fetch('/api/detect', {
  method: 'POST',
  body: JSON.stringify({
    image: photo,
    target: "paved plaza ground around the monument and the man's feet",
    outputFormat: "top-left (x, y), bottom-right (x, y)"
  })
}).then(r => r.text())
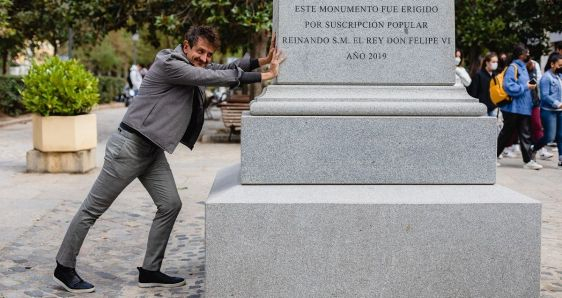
top-left (0, 108), bottom-right (562, 297)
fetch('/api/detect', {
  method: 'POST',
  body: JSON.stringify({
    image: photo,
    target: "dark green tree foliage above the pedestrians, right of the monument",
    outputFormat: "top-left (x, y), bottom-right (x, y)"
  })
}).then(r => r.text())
top-left (455, 0), bottom-right (562, 74)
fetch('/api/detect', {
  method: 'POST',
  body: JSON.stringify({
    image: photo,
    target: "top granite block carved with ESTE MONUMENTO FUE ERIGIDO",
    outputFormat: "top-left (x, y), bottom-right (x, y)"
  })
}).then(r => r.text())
top-left (273, 0), bottom-right (455, 85)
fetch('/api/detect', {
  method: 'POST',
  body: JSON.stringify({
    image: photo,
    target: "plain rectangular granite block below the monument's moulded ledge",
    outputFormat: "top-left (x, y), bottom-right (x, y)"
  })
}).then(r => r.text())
top-left (241, 114), bottom-right (497, 184)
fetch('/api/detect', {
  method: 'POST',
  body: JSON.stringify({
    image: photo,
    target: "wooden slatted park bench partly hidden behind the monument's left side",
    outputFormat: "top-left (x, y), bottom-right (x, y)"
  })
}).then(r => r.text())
top-left (218, 94), bottom-right (250, 142)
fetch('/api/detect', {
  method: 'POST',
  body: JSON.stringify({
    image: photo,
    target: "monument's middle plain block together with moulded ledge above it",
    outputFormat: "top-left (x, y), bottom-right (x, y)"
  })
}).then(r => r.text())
top-left (241, 86), bottom-right (497, 185)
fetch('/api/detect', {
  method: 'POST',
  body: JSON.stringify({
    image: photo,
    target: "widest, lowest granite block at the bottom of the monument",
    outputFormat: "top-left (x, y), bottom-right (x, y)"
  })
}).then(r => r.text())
top-left (205, 167), bottom-right (541, 298)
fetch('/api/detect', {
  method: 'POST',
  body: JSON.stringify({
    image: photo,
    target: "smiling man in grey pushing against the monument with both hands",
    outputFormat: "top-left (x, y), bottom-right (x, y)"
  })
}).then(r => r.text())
top-left (54, 26), bottom-right (281, 293)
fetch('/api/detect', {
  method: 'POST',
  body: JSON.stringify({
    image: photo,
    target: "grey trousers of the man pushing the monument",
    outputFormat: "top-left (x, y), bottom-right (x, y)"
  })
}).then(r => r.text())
top-left (57, 129), bottom-right (182, 271)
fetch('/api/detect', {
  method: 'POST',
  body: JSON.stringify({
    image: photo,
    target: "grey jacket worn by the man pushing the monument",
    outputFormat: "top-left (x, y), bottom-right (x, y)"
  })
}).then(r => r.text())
top-left (123, 45), bottom-right (261, 153)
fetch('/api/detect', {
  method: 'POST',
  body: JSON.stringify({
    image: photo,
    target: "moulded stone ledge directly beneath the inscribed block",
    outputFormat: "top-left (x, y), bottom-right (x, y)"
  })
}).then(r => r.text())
top-left (250, 85), bottom-right (486, 117)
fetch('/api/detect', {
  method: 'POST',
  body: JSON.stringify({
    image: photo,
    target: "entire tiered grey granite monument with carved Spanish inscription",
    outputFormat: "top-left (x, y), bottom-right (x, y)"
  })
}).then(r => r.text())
top-left (206, 0), bottom-right (541, 297)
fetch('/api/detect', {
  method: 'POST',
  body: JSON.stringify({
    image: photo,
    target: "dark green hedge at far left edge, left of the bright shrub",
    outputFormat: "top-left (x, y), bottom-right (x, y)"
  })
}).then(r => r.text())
top-left (0, 76), bottom-right (26, 116)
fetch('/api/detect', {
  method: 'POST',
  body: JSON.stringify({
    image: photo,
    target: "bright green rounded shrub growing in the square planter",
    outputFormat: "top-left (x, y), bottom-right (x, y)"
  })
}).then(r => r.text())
top-left (22, 57), bottom-right (100, 116)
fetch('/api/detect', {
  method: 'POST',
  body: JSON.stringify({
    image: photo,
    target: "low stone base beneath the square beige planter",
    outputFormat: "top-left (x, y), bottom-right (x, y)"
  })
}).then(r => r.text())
top-left (27, 148), bottom-right (96, 173)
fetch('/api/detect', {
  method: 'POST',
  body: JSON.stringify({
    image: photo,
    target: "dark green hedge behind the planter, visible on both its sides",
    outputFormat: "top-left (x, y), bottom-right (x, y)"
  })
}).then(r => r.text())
top-left (0, 75), bottom-right (125, 116)
